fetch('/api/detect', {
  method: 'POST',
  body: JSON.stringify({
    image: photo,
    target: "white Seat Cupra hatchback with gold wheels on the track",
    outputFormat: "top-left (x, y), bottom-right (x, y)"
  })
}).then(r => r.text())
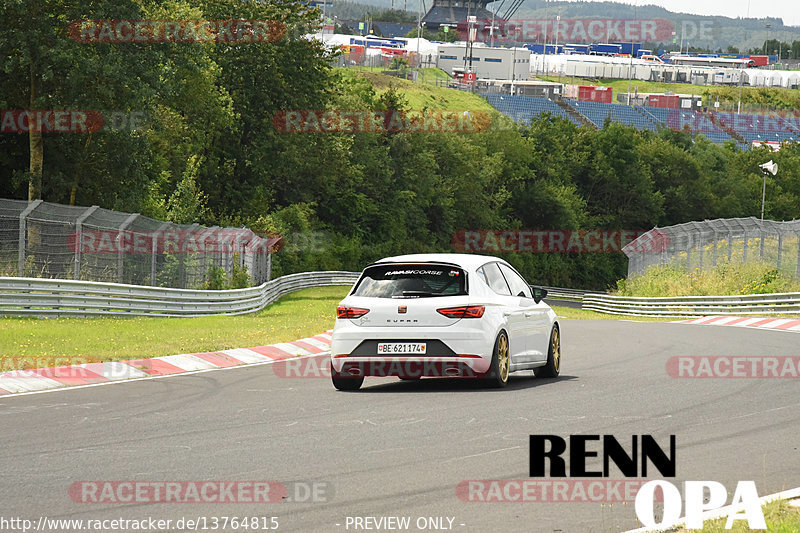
top-left (331, 254), bottom-right (561, 390)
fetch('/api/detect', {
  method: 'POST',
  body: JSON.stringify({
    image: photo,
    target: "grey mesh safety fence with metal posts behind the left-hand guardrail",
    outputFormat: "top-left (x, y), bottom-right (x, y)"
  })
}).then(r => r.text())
top-left (0, 199), bottom-right (280, 288)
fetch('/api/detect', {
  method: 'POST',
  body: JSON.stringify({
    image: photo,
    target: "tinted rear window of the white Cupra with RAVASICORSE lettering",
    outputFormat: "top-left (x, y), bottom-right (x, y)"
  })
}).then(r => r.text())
top-left (353, 264), bottom-right (467, 298)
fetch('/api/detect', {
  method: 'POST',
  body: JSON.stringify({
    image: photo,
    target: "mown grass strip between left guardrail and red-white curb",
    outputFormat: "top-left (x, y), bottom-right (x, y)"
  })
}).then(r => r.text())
top-left (0, 287), bottom-right (348, 370)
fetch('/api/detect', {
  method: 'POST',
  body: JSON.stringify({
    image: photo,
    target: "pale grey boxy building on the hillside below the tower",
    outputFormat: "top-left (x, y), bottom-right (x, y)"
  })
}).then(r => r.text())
top-left (436, 43), bottom-right (531, 80)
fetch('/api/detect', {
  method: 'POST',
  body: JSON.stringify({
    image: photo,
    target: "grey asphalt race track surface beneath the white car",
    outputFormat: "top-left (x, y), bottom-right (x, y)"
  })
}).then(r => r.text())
top-left (0, 321), bottom-right (800, 533)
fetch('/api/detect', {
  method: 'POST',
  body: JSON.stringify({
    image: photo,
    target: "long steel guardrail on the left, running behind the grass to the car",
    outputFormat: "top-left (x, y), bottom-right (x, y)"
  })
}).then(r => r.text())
top-left (0, 271), bottom-right (359, 317)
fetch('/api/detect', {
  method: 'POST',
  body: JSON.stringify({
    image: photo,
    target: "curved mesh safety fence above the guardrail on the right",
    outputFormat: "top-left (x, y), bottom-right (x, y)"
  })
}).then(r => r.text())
top-left (622, 217), bottom-right (800, 278)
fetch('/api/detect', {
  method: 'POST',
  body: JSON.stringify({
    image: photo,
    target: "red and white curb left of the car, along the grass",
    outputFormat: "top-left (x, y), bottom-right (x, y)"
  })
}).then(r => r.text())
top-left (0, 331), bottom-right (331, 396)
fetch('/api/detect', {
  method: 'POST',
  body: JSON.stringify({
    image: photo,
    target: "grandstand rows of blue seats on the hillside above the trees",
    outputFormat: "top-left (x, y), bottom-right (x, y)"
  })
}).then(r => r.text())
top-left (484, 94), bottom-right (800, 148)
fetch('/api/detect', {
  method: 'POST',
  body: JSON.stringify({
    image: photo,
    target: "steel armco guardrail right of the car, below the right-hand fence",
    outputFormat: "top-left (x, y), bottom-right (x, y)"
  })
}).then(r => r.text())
top-left (581, 292), bottom-right (800, 317)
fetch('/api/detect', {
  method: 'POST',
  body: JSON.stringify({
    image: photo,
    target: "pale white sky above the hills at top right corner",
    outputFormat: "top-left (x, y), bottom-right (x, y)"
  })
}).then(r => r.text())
top-left (621, 0), bottom-right (800, 26)
